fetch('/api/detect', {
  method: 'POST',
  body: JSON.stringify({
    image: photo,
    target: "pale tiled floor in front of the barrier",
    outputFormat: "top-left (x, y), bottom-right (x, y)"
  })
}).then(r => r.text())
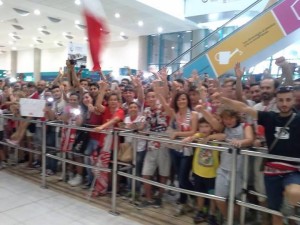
top-left (0, 170), bottom-right (140, 225)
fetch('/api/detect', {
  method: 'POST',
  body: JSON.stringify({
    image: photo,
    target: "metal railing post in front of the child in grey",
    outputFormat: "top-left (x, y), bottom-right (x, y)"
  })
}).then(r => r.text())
top-left (227, 148), bottom-right (237, 225)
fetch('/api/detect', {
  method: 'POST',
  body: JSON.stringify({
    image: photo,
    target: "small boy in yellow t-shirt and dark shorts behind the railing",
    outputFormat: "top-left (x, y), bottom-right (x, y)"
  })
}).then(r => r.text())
top-left (183, 118), bottom-right (219, 225)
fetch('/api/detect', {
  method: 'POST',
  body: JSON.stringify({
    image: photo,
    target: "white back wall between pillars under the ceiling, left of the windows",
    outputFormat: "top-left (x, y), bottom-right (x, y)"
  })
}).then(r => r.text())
top-left (0, 38), bottom-right (139, 76)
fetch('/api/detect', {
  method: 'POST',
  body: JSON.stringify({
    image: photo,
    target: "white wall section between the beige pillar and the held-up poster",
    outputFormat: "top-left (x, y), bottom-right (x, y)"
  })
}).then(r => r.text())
top-left (41, 47), bottom-right (68, 72)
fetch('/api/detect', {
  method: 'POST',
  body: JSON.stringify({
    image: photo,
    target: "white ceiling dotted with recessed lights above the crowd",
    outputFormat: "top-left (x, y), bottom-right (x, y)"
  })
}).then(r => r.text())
top-left (0, 0), bottom-right (197, 51)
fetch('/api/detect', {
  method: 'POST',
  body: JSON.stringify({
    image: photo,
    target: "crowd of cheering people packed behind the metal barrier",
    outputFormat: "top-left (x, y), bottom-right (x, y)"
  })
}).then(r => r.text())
top-left (0, 58), bottom-right (300, 225)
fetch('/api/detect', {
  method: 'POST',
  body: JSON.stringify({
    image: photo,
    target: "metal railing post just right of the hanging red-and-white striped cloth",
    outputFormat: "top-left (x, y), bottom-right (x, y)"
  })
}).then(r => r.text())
top-left (110, 131), bottom-right (119, 216)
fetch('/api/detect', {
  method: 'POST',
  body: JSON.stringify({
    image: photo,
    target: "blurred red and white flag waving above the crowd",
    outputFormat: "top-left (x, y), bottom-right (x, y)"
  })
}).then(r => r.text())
top-left (83, 0), bottom-right (108, 71)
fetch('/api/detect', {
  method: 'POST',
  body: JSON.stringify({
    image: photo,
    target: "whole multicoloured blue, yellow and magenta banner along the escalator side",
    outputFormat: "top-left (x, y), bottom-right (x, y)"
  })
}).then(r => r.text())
top-left (184, 0), bottom-right (300, 77)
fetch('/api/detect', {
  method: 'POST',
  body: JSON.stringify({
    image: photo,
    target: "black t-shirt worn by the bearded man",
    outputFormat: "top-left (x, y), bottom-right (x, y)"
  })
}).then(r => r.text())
top-left (257, 111), bottom-right (300, 164)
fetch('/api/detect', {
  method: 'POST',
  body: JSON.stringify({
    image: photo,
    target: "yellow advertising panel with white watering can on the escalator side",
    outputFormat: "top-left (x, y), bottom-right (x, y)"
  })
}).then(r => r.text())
top-left (207, 12), bottom-right (285, 76)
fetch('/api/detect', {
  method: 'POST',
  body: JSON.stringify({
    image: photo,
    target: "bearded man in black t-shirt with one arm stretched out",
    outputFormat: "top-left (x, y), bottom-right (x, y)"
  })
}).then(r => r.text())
top-left (213, 86), bottom-right (300, 225)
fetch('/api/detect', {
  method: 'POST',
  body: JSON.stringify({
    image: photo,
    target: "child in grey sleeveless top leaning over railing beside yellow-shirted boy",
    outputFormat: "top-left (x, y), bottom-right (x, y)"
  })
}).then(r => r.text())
top-left (204, 109), bottom-right (254, 223)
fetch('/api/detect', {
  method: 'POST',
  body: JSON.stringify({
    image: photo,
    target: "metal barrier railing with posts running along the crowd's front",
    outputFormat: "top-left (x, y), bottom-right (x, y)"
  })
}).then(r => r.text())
top-left (0, 112), bottom-right (300, 224)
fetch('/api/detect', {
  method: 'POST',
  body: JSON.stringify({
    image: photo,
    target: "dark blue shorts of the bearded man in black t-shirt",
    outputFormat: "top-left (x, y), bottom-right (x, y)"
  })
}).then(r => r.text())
top-left (265, 172), bottom-right (300, 211)
